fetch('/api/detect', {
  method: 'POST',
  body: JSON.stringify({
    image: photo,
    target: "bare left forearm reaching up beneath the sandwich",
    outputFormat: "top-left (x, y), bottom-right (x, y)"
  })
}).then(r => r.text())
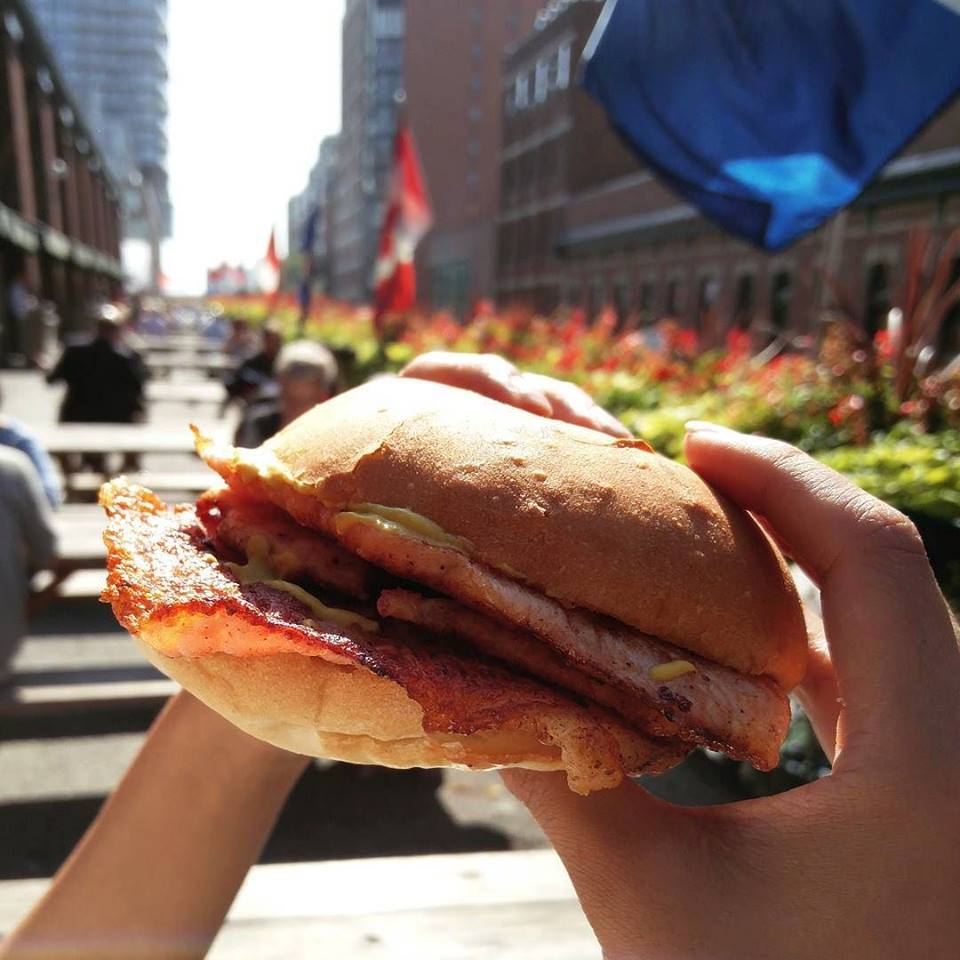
top-left (0, 693), bottom-right (307, 960)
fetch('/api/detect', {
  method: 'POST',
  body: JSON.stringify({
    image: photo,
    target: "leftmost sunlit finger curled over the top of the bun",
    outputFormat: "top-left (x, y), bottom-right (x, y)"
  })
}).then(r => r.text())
top-left (400, 351), bottom-right (553, 417)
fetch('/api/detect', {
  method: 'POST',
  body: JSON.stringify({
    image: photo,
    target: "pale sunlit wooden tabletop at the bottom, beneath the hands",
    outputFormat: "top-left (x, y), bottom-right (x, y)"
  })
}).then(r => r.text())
top-left (0, 852), bottom-right (600, 960)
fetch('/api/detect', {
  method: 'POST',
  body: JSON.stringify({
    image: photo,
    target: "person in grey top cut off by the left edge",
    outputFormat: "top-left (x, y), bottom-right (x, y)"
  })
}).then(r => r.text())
top-left (0, 447), bottom-right (56, 686)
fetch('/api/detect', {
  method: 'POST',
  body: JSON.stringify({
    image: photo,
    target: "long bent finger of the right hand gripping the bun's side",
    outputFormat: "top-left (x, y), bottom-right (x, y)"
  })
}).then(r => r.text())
top-left (686, 424), bottom-right (960, 752)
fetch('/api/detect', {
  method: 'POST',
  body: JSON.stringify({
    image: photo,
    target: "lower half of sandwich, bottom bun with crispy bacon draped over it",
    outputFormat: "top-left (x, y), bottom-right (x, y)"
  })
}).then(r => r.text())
top-left (100, 480), bottom-right (689, 793)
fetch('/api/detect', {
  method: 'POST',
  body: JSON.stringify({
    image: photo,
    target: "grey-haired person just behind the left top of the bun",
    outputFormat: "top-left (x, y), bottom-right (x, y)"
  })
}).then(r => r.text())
top-left (234, 340), bottom-right (339, 447)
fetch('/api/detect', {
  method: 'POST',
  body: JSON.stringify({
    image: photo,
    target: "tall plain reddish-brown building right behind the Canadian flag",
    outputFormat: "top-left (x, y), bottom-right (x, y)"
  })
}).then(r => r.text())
top-left (404, 0), bottom-right (542, 314)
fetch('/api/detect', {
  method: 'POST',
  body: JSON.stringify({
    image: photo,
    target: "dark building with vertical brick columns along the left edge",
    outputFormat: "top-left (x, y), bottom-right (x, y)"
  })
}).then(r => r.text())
top-left (0, 0), bottom-right (123, 351)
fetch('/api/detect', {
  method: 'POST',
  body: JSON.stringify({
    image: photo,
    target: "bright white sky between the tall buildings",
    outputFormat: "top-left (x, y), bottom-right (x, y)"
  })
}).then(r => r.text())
top-left (124, 0), bottom-right (344, 294)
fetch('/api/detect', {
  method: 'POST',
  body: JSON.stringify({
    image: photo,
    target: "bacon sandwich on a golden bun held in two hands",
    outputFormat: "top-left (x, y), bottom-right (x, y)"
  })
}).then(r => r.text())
top-left (101, 378), bottom-right (806, 793)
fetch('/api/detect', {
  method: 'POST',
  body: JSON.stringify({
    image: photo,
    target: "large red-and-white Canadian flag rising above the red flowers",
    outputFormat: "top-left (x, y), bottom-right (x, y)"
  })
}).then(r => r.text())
top-left (373, 123), bottom-right (433, 331)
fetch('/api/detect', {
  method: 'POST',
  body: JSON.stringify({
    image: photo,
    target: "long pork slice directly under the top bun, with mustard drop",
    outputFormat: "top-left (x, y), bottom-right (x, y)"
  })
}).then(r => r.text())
top-left (336, 514), bottom-right (790, 770)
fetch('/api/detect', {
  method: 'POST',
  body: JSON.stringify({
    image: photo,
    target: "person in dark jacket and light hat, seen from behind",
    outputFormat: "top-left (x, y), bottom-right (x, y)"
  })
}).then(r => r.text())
top-left (47, 303), bottom-right (146, 423)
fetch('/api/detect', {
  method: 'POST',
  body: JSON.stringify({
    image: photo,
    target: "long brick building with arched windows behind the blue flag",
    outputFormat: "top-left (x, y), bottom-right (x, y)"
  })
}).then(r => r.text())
top-left (496, 0), bottom-right (960, 344)
